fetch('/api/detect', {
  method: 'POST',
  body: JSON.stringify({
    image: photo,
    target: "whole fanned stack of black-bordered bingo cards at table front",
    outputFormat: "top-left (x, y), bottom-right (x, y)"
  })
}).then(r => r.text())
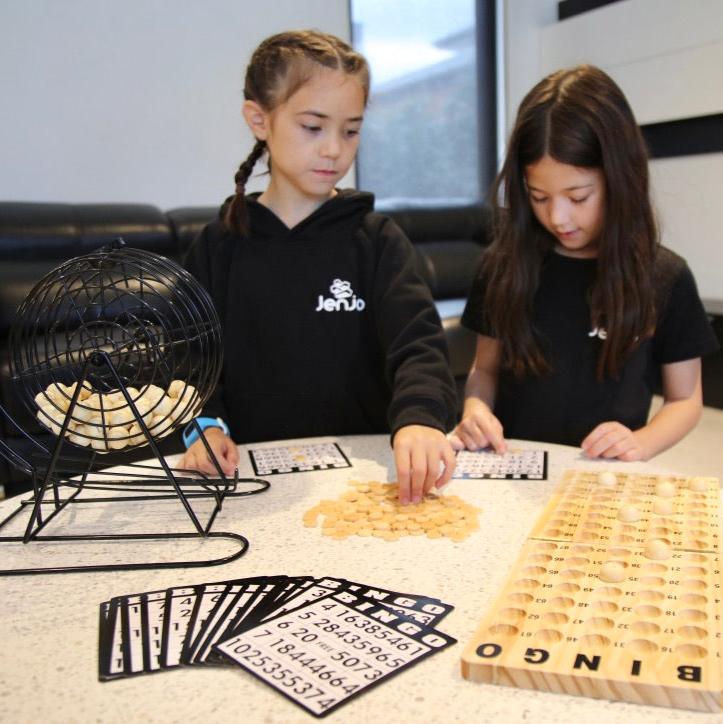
top-left (98, 576), bottom-right (456, 716)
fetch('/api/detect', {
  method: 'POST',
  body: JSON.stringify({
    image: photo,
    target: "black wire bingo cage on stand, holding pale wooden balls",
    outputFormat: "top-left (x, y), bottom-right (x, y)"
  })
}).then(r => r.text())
top-left (0, 239), bottom-right (269, 575)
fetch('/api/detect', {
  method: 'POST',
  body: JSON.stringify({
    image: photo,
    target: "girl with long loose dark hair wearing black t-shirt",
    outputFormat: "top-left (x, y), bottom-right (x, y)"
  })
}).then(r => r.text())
top-left (452, 65), bottom-right (717, 460)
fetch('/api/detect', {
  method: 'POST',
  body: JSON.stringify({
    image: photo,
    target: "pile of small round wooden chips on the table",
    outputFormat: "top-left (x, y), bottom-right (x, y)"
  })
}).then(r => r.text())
top-left (304, 481), bottom-right (480, 541)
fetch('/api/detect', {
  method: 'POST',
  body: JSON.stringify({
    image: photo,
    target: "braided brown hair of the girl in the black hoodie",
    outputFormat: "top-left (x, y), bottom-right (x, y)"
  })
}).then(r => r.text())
top-left (222, 30), bottom-right (369, 234)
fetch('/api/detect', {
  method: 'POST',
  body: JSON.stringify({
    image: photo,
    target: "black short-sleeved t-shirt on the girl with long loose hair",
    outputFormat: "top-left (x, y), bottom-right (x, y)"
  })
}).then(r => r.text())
top-left (462, 248), bottom-right (718, 445)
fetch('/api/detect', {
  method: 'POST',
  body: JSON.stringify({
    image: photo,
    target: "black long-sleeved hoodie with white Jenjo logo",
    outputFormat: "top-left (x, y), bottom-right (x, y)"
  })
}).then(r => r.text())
top-left (186, 190), bottom-right (455, 443)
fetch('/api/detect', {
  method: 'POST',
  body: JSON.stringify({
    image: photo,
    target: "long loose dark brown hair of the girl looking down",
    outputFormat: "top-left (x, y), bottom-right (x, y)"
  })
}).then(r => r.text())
top-left (481, 65), bottom-right (659, 379)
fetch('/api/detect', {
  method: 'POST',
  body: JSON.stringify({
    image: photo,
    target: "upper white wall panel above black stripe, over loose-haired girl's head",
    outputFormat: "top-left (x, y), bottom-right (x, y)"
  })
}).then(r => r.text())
top-left (540, 0), bottom-right (723, 124)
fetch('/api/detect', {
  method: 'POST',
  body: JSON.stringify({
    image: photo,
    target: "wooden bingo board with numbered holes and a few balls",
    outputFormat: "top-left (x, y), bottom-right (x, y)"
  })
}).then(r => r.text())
top-left (462, 471), bottom-right (723, 711)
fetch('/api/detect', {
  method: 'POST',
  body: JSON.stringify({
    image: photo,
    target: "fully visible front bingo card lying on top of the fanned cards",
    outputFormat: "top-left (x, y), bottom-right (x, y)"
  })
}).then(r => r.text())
top-left (216, 590), bottom-right (456, 717)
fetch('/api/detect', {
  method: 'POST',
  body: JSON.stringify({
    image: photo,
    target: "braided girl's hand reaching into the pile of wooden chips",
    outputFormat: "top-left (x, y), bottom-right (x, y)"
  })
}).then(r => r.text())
top-left (393, 425), bottom-right (455, 505)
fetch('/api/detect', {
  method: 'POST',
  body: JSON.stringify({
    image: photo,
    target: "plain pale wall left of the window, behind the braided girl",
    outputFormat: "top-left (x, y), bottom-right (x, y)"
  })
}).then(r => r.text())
top-left (0, 0), bottom-right (350, 208)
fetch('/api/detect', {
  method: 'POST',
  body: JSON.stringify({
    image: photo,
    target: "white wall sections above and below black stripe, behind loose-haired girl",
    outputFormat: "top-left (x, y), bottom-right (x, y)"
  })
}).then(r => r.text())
top-left (505, 0), bottom-right (723, 308)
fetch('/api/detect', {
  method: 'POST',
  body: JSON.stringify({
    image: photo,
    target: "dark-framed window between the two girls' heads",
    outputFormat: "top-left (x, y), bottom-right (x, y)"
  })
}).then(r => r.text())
top-left (351, 0), bottom-right (496, 209)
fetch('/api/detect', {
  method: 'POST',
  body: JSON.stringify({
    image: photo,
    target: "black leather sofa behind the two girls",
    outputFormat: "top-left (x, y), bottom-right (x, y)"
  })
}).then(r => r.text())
top-left (0, 202), bottom-right (488, 494)
